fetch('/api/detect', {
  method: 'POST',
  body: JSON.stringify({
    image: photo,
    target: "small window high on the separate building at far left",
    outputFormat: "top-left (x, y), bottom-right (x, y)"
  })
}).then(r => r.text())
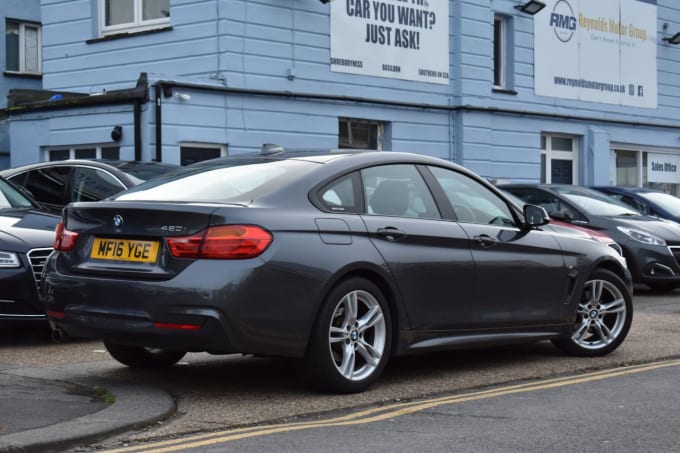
top-left (5, 20), bottom-right (42, 74)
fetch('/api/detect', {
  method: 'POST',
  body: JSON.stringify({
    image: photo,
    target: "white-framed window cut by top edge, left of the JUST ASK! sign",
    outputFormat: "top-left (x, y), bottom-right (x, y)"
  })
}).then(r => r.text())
top-left (99, 0), bottom-right (170, 35)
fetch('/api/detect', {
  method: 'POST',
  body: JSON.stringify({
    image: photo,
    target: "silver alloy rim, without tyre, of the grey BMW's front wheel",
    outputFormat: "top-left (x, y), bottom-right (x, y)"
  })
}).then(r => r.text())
top-left (571, 280), bottom-right (627, 349)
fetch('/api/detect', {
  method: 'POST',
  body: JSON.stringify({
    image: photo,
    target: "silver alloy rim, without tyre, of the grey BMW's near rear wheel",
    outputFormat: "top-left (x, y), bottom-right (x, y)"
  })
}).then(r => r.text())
top-left (328, 290), bottom-right (387, 381)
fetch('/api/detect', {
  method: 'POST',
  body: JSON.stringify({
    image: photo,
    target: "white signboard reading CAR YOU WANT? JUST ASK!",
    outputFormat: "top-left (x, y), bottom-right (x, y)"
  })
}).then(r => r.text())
top-left (330, 0), bottom-right (449, 84)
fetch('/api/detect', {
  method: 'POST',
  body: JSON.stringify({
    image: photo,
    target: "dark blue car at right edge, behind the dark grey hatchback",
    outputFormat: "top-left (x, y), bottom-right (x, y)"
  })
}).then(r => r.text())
top-left (593, 186), bottom-right (680, 222)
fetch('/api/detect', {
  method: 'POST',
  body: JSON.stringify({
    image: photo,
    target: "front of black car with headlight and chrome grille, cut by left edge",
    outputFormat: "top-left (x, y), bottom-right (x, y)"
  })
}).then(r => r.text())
top-left (0, 178), bottom-right (60, 324)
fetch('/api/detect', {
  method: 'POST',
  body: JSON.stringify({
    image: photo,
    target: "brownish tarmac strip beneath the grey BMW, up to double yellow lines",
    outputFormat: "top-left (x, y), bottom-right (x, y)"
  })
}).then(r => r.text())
top-left (0, 284), bottom-right (680, 451)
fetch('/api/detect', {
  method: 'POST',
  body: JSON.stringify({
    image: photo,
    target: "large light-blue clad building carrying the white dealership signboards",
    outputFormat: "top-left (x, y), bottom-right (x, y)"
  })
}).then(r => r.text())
top-left (7, 0), bottom-right (680, 194)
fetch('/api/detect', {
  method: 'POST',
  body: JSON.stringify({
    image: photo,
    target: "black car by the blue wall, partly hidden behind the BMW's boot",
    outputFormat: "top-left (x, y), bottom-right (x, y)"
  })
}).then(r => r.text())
top-left (0, 159), bottom-right (178, 214)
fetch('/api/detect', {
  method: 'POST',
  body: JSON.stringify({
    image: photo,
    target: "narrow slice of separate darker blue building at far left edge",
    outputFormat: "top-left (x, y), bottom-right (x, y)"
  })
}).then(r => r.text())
top-left (0, 0), bottom-right (42, 168)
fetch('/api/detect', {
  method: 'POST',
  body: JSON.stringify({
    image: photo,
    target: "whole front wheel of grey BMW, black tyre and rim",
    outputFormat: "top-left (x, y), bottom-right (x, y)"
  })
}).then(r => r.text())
top-left (553, 269), bottom-right (633, 357)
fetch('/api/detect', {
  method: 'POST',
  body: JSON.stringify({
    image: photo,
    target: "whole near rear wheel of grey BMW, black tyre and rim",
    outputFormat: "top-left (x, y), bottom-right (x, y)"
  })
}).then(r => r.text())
top-left (305, 278), bottom-right (392, 393)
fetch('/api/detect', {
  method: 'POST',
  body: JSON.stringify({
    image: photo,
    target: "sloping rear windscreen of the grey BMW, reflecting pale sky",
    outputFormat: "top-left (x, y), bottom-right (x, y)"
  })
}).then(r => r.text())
top-left (114, 160), bottom-right (319, 203)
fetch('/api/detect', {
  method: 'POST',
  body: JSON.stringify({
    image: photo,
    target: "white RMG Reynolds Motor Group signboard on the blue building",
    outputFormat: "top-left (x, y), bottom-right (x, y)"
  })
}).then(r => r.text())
top-left (534, 0), bottom-right (658, 108)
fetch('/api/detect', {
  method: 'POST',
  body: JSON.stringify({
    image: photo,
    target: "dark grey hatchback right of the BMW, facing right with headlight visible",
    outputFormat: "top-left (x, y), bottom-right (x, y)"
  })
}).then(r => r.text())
top-left (500, 184), bottom-right (680, 290)
